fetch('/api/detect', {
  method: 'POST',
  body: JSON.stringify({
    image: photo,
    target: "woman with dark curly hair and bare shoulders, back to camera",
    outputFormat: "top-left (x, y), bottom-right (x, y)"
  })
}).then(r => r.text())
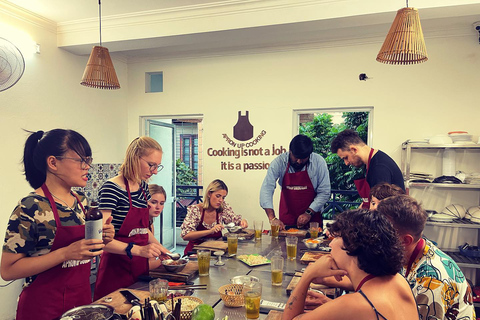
top-left (283, 209), bottom-right (418, 320)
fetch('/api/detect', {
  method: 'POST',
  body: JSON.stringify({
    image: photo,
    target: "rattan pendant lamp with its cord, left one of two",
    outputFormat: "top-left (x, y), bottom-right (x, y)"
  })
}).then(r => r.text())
top-left (80, 0), bottom-right (120, 90)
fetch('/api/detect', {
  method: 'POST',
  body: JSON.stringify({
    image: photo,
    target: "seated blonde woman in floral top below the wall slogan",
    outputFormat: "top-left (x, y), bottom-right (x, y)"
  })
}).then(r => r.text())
top-left (181, 179), bottom-right (248, 254)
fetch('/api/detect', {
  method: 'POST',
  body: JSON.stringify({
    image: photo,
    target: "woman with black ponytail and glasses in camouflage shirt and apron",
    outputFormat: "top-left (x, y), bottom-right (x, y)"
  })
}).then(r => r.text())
top-left (1, 129), bottom-right (114, 320)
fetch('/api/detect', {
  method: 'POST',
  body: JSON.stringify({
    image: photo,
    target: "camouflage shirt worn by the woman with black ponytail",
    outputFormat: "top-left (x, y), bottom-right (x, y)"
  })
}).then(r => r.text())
top-left (3, 192), bottom-right (87, 285)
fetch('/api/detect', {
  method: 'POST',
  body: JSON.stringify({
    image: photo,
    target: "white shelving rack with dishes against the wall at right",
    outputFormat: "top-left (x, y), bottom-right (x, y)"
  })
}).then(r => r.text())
top-left (401, 141), bottom-right (480, 292)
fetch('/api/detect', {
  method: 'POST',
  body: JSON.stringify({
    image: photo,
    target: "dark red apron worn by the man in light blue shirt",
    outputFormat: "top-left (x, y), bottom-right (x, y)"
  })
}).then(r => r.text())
top-left (279, 162), bottom-right (322, 227)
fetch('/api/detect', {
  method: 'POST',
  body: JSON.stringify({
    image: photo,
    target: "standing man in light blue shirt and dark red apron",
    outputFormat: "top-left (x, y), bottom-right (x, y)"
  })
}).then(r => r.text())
top-left (260, 135), bottom-right (330, 229)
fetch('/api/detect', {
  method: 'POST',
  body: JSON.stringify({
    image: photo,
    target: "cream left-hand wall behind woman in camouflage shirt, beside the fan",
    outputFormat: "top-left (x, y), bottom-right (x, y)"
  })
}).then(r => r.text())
top-left (0, 8), bottom-right (128, 319)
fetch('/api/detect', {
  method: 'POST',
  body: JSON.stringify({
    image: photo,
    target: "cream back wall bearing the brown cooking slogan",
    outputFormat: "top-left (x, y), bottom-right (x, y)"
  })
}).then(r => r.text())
top-left (128, 34), bottom-right (480, 228)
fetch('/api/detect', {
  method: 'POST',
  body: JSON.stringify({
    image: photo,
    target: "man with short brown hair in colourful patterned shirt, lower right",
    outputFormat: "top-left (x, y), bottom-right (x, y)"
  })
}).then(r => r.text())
top-left (377, 195), bottom-right (476, 320)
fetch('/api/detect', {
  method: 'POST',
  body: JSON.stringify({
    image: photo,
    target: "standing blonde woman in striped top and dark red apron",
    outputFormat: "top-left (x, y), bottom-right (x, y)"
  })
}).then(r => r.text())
top-left (94, 137), bottom-right (170, 300)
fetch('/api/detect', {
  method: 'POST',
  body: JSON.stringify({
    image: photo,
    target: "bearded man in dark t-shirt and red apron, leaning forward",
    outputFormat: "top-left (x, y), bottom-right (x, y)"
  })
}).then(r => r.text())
top-left (331, 129), bottom-right (405, 209)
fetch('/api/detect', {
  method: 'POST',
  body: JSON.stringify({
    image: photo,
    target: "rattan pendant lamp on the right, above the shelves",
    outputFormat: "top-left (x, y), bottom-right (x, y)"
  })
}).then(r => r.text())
top-left (377, 0), bottom-right (428, 65)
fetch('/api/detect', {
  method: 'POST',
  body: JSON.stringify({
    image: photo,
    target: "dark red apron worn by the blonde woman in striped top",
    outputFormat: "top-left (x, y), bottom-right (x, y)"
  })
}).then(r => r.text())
top-left (93, 179), bottom-right (149, 300)
